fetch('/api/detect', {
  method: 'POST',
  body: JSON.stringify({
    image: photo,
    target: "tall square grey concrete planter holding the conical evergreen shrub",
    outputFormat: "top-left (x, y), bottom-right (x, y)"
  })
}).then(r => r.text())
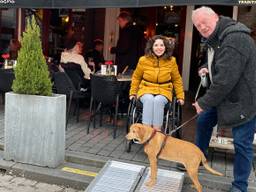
top-left (4, 92), bottom-right (66, 167)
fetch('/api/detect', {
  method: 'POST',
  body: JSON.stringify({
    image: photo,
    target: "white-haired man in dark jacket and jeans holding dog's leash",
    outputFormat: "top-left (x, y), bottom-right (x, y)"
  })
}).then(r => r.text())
top-left (192, 7), bottom-right (256, 192)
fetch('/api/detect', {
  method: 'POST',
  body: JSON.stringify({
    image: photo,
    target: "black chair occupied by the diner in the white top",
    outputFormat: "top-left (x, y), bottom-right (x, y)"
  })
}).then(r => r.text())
top-left (53, 72), bottom-right (90, 127)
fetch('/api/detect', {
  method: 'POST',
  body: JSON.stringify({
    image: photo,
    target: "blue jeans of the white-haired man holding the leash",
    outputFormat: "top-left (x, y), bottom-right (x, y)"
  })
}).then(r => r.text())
top-left (196, 108), bottom-right (256, 192)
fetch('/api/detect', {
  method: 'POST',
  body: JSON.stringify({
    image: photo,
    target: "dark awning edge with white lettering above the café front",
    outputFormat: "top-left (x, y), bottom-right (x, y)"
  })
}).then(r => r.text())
top-left (0, 0), bottom-right (248, 8)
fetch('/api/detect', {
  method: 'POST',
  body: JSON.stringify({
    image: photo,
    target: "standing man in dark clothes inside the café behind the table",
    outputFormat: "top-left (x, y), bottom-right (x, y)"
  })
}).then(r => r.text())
top-left (110, 11), bottom-right (145, 73)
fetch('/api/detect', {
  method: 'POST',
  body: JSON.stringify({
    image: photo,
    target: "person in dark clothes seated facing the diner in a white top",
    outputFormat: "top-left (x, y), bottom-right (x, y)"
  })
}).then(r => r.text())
top-left (85, 39), bottom-right (105, 72)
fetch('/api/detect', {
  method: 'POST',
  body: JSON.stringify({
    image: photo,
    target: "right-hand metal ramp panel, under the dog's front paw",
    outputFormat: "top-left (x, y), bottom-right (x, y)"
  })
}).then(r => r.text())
top-left (136, 168), bottom-right (184, 192)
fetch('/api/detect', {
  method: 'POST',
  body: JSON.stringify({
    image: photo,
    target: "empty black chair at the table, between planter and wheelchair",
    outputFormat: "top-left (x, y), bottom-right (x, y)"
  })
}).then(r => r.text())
top-left (87, 75), bottom-right (119, 138)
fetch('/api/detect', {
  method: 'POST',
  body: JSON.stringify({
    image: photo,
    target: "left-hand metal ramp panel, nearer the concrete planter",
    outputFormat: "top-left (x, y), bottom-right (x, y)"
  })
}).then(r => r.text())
top-left (85, 161), bottom-right (145, 192)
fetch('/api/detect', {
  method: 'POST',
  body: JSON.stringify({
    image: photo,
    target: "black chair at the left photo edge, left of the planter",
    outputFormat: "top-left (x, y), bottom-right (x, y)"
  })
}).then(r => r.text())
top-left (0, 69), bottom-right (15, 104)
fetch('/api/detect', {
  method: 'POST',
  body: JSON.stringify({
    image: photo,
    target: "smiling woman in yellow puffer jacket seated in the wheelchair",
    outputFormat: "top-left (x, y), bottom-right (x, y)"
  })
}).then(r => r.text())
top-left (130, 35), bottom-right (184, 130)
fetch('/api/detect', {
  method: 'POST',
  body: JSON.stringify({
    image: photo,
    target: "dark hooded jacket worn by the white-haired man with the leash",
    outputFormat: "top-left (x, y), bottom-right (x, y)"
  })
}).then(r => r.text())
top-left (198, 16), bottom-right (256, 127)
